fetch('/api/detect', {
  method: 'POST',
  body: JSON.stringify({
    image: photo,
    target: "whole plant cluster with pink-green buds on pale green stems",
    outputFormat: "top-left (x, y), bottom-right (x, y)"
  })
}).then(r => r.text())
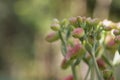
top-left (46, 16), bottom-right (120, 80)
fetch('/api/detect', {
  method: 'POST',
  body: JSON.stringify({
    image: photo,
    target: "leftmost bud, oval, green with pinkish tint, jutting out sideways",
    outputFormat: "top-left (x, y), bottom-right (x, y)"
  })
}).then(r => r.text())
top-left (45, 32), bottom-right (59, 42)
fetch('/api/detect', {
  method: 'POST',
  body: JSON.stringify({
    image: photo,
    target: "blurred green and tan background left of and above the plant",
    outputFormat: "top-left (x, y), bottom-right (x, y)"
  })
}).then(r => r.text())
top-left (0, 0), bottom-right (120, 80)
